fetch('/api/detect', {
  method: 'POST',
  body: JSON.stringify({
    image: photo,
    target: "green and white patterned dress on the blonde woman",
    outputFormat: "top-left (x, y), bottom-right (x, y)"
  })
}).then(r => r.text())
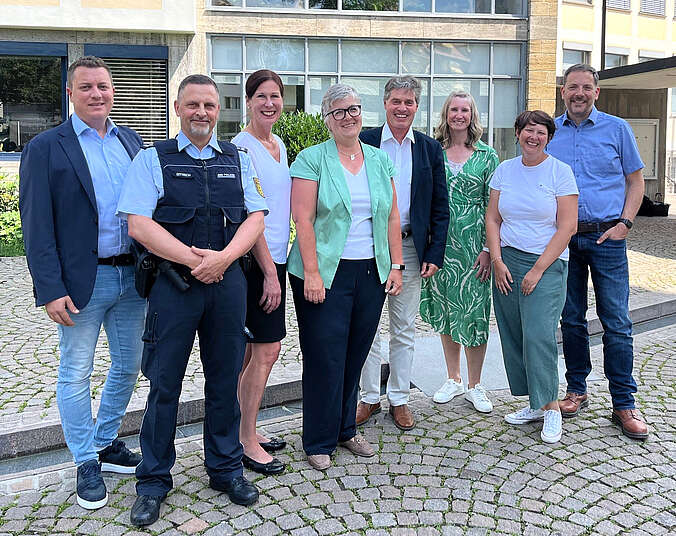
top-left (420, 141), bottom-right (500, 346)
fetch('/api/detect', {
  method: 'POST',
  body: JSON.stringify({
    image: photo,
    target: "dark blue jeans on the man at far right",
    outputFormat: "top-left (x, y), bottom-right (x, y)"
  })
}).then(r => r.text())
top-left (561, 233), bottom-right (637, 409)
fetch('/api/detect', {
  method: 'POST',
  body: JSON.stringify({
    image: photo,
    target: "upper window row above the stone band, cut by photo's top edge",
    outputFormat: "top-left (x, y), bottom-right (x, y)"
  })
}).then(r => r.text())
top-left (207, 0), bottom-right (525, 15)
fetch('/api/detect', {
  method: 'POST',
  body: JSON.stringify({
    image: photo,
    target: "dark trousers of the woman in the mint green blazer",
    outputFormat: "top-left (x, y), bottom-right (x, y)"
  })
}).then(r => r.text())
top-left (289, 259), bottom-right (385, 455)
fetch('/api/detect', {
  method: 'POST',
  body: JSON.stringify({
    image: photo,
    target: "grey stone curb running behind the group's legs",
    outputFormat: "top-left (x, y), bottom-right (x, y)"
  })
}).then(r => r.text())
top-left (0, 299), bottom-right (676, 460)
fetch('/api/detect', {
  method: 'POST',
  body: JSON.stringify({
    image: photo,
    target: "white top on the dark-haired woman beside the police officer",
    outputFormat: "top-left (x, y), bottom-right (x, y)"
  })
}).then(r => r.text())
top-left (232, 132), bottom-right (291, 264)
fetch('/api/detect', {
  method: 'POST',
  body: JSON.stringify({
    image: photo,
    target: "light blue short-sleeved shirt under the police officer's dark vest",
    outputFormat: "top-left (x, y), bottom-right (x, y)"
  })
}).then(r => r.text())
top-left (117, 132), bottom-right (268, 219)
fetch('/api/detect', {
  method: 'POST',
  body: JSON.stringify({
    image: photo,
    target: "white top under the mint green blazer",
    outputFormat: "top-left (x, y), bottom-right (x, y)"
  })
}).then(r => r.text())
top-left (340, 164), bottom-right (376, 259)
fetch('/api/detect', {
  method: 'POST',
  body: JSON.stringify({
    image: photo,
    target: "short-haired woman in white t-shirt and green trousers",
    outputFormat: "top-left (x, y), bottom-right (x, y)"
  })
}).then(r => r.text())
top-left (486, 110), bottom-right (578, 443)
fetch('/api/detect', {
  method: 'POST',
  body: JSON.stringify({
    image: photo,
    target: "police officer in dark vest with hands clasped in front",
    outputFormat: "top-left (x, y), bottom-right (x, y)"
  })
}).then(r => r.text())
top-left (118, 75), bottom-right (267, 526)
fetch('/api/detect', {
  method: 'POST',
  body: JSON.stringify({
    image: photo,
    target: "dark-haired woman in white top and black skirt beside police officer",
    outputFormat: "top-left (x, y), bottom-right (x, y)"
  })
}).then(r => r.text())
top-left (232, 69), bottom-right (291, 475)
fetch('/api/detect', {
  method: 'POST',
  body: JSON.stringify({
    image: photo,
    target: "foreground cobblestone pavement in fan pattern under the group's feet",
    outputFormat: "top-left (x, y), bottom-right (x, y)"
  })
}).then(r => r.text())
top-left (0, 325), bottom-right (676, 536)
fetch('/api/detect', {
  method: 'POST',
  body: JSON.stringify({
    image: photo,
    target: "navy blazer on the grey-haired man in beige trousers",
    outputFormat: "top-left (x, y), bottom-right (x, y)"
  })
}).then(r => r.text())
top-left (359, 127), bottom-right (449, 268)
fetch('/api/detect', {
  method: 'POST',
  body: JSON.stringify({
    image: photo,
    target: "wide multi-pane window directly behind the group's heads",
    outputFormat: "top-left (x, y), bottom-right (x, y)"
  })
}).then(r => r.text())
top-left (211, 37), bottom-right (523, 158)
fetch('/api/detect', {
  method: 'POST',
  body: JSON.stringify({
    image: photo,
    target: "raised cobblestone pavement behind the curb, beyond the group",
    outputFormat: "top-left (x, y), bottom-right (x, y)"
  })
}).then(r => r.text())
top-left (0, 217), bottom-right (676, 433)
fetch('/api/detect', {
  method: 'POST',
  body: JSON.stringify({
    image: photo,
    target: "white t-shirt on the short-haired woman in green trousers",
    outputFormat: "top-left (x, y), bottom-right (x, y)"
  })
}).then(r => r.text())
top-left (490, 156), bottom-right (578, 260)
